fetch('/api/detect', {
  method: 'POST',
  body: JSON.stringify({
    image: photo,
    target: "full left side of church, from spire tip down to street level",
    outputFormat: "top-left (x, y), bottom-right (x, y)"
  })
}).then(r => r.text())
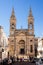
top-left (9, 8), bottom-right (16, 56)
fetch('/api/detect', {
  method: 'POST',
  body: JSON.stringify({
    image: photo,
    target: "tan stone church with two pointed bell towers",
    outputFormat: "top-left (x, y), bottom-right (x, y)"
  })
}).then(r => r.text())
top-left (9, 8), bottom-right (38, 57)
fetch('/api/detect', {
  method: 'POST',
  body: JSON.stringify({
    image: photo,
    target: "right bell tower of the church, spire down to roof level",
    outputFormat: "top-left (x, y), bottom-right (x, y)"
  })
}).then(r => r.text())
top-left (28, 8), bottom-right (34, 35)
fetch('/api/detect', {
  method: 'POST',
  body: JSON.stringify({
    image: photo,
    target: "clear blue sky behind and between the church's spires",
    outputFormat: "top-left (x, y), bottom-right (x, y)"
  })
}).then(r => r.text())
top-left (0, 0), bottom-right (43, 37)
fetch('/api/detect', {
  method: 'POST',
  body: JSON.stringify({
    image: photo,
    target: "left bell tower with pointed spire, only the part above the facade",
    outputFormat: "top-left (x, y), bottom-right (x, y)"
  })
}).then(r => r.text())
top-left (10, 8), bottom-right (16, 35)
